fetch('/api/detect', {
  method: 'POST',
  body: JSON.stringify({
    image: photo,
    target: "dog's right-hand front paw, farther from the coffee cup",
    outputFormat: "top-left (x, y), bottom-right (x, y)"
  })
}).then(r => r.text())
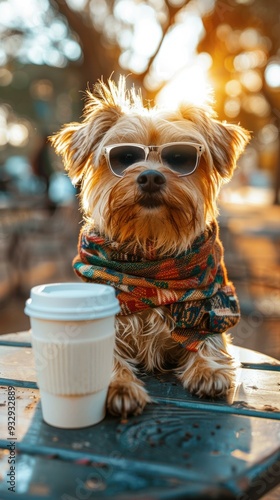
top-left (177, 334), bottom-right (235, 397)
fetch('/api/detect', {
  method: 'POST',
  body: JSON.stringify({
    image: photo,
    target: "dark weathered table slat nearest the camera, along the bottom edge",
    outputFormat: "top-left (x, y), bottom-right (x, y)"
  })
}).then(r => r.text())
top-left (0, 454), bottom-right (240, 500)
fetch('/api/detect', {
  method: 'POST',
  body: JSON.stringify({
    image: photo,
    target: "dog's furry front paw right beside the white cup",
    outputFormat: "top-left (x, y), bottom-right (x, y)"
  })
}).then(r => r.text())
top-left (107, 379), bottom-right (151, 418)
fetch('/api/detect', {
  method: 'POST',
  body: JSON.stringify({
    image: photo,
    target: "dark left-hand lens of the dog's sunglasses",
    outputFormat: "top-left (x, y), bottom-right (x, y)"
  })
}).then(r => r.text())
top-left (109, 145), bottom-right (145, 175)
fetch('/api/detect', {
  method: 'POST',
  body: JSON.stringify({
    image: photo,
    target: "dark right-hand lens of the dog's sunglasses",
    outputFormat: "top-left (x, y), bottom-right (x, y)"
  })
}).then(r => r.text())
top-left (161, 144), bottom-right (198, 175)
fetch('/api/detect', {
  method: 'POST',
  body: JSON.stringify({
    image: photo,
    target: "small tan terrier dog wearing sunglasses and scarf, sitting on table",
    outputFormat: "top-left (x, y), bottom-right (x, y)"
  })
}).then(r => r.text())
top-left (51, 77), bottom-right (249, 417)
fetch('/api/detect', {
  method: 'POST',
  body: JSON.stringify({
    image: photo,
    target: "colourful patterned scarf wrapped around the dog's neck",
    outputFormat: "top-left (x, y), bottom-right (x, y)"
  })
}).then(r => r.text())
top-left (73, 223), bottom-right (240, 351)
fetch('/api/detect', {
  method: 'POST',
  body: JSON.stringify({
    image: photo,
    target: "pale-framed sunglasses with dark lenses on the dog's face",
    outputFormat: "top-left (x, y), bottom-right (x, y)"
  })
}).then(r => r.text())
top-left (103, 142), bottom-right (204, 177)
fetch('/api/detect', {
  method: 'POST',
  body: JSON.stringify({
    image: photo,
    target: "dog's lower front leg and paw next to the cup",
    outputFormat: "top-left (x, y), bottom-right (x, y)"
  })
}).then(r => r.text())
top-left (107, 359), bottom-right (151, 418)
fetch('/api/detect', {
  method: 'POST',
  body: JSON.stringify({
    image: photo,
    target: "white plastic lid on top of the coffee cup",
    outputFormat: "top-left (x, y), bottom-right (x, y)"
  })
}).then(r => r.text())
top-left (24, 283), bottom-right (120, 321)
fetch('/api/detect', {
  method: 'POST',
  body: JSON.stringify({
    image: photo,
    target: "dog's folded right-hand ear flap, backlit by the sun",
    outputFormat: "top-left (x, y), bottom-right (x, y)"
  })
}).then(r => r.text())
top-left (207, 119), bottom-right (250, 182)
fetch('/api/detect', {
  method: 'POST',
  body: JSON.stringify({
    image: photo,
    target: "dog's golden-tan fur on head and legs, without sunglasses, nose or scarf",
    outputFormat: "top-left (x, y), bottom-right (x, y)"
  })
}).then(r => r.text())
top-left (51, 78), bottom-right (249, 416)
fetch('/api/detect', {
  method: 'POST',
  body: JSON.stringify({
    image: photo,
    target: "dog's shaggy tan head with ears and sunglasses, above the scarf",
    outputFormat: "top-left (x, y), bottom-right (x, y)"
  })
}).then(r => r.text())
top-left (51, 78), bottom-right (249, 254)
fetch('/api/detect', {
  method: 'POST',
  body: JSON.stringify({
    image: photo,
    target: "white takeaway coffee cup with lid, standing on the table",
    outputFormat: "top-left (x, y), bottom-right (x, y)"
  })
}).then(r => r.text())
top-left (25, 283), bottom-right (120, 428)
